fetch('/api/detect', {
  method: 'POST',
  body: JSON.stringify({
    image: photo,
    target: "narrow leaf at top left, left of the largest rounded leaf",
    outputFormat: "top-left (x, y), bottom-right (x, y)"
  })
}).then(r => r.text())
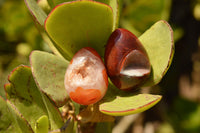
top-left (24, 0), bottom-right (47, 26)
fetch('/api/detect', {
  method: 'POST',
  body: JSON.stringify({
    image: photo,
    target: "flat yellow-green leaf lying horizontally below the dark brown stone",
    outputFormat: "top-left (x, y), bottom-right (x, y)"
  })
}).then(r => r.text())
top-left (100, 94), bottom-right (161, 116)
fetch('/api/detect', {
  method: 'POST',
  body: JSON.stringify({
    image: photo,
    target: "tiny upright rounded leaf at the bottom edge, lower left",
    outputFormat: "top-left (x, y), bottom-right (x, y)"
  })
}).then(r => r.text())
top-left (35, 115), bottom-right (49, 133)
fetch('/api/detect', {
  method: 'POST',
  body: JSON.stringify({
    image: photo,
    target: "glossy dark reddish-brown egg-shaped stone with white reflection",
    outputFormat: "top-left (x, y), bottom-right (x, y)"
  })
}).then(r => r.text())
top-left (104, 28), bottom-right (151, 90)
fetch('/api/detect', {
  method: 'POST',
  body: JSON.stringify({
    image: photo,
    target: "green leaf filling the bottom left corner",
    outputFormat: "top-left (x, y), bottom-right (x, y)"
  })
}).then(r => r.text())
top-left (0, 97), bottom-right (33, 133)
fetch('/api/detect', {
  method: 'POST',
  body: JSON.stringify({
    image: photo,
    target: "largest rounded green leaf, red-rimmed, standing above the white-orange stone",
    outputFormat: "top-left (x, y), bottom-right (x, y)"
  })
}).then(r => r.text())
top-left (45, 1), bottom-right (113, 59)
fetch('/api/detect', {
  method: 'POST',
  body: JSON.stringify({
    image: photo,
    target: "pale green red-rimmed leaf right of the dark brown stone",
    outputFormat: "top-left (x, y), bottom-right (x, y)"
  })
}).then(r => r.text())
top-left (139, 20), bottom-right (174, 86)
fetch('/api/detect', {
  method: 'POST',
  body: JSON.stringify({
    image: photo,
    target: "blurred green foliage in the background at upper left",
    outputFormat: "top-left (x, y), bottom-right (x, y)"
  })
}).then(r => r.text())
top-left (0, 0), bottom-right (48, 96)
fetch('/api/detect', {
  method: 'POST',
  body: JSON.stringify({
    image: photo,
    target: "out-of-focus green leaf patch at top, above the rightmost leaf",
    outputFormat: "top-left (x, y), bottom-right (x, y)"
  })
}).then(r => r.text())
top-left (121, 0), bottom-right (171, 35)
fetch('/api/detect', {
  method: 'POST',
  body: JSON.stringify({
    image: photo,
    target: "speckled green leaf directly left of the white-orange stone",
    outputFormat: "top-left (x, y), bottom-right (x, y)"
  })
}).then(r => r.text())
top-left (30, 51), bottom-right (69, 107)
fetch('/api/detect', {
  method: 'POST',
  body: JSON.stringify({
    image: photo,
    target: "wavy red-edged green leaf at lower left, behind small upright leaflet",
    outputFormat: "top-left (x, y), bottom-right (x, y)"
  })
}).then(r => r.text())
top-left (5, 66), bottom-right (63, 131)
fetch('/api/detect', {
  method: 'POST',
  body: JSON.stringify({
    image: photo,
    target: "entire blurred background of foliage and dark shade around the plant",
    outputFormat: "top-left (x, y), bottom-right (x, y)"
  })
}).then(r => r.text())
top-left (0, 0), bottom-right (200, 133)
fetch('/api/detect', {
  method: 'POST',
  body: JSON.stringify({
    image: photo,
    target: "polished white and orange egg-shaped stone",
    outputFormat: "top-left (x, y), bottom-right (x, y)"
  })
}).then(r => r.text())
top-left (64, 47), bottom-right (108, 105)
